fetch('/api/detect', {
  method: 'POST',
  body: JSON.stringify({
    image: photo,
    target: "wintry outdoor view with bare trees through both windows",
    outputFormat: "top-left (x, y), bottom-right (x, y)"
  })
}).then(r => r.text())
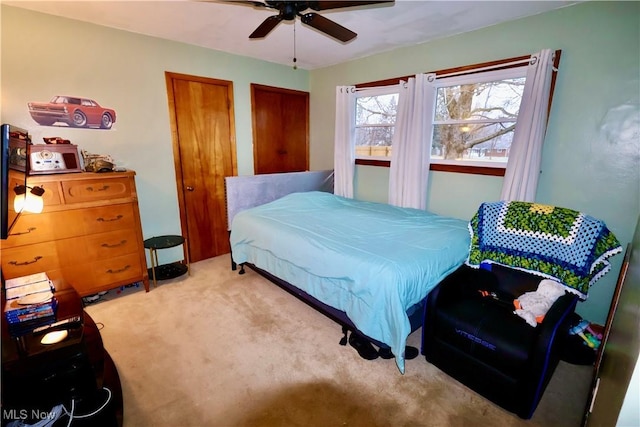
top-left (355, 69), bottom-right (526, 167)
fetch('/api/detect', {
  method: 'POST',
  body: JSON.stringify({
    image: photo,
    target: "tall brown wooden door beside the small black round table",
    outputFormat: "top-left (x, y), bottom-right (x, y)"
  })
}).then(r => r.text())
top-left (165, 72), bottom-right (237, 262)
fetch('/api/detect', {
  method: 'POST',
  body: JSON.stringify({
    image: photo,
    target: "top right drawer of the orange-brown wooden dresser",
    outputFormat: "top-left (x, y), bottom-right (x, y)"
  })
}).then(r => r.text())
top-left (62, 174), bottom-right (133, 204)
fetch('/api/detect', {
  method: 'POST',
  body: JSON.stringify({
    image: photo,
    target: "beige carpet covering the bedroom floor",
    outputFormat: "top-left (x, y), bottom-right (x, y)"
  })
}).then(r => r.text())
top-left (86, 255), bottom-right (591, 427)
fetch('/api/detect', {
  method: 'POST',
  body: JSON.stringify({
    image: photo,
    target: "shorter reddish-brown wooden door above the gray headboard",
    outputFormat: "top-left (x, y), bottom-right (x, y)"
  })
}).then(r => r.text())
top-left (251, 84), bottom-right (309, 174)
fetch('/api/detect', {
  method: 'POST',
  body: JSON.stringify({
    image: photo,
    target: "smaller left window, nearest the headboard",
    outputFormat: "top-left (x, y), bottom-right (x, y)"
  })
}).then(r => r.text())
top-left (355, 85), bottom-right (398, 160)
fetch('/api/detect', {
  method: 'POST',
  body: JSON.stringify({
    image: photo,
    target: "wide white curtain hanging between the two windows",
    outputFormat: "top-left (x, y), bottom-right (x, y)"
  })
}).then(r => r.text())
top-left (389, 74), bottom-right (435, 209)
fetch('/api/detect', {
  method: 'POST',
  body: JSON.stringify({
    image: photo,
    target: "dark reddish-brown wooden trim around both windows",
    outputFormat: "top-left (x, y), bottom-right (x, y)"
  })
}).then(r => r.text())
top-left (355, 49), bottom-right (562, 176)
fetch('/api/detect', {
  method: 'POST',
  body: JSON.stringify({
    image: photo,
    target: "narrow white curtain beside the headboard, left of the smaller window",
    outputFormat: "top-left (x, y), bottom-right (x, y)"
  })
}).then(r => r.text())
top-left (333, 86), bottom-right (356, 198)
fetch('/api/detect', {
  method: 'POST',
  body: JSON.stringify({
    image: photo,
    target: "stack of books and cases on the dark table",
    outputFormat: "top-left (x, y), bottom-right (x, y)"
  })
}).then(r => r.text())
top-left (4, 273), bottom-right (58, 336)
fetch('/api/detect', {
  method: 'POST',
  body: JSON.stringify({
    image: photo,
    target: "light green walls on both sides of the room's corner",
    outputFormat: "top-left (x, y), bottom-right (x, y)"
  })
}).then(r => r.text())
top-left (0, 1), bottom-right (640, 322)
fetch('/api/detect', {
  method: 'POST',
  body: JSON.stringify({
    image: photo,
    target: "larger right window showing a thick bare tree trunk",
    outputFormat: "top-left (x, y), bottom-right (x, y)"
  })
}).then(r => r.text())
top-left (431, 67), bottom-right (527, 168)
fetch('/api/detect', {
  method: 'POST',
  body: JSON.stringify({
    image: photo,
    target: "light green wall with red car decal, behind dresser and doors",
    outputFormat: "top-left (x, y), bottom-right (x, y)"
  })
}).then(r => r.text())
top-left (1, 5), bottom-right (309, 262)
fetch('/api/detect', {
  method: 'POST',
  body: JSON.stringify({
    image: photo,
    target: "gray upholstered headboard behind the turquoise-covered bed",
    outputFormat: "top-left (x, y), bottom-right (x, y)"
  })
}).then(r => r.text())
top-left (224, 170), bottom-right (333, 230)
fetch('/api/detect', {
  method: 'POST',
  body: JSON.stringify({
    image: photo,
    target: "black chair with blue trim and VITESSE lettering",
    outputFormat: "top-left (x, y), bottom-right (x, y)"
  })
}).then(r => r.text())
top-left (422, 264), bottom-right (578, 419)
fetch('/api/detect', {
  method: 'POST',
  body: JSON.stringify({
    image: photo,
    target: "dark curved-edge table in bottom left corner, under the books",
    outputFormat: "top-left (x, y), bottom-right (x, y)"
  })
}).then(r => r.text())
top-left (0, 290), bottom-right (124, 427)
